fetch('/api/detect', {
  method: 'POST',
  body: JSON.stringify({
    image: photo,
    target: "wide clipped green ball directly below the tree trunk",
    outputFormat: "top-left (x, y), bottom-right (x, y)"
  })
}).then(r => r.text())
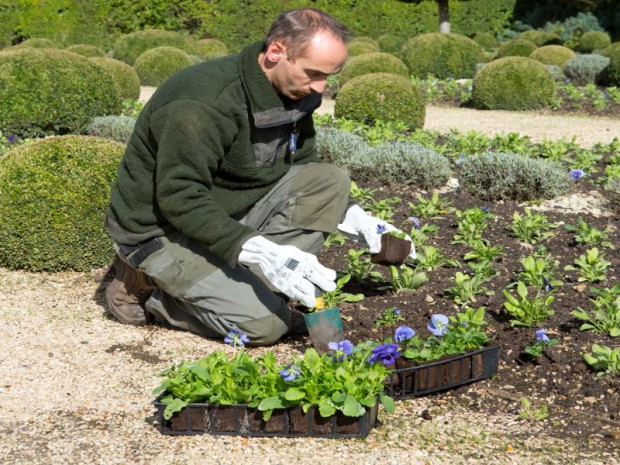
top-left (401, 32), bottom-right (483, 79)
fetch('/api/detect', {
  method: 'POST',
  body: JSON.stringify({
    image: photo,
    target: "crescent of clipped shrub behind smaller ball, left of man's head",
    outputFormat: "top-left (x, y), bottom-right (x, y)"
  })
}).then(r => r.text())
top-left (112, 29), bottom-right (196, 65)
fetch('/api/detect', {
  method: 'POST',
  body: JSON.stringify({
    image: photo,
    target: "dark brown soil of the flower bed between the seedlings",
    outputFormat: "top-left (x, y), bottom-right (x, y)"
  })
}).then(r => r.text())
top-left (319, 150), bottom-right (620, 448)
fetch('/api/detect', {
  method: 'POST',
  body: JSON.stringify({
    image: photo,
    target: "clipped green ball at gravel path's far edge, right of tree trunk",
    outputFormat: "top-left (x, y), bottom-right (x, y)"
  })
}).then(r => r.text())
top-left (472, 57), bottom-right (555, 110)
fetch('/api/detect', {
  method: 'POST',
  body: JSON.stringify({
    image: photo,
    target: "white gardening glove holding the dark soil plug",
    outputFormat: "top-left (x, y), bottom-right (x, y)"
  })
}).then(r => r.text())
top-left (338, 205), bottom-right (416, 258)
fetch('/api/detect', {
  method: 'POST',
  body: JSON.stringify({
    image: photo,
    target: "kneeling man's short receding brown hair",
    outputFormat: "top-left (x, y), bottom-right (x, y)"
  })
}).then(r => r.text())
top-left (267, 8), bottom-right (349, 60)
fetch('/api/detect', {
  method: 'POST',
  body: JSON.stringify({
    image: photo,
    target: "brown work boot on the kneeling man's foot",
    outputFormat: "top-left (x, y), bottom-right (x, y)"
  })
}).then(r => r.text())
top-left (105, 256), bottom-right (155, 326)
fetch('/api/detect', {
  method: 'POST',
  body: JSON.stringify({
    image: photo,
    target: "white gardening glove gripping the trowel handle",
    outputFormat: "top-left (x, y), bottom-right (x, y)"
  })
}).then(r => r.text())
top-left (239, 236), bottom-right (336, 308)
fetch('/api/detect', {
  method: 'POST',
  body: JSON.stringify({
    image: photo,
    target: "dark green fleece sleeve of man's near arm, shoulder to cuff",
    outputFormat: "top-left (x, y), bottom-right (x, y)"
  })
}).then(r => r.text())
top-left (151, 100), bottom-right (256, 264)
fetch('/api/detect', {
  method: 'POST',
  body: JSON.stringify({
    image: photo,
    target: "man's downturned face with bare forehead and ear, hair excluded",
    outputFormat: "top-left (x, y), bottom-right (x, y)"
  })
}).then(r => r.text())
top-left (269, 32), bottom-right (347, 100)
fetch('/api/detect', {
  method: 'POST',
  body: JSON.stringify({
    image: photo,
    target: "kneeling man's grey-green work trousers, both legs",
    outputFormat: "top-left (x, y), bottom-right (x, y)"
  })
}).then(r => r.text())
top-left (123, 163), bottom-right (350, 345)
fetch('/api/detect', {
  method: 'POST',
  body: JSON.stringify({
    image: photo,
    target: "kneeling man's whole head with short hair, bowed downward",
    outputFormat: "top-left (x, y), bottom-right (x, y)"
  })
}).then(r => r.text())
top-left (259, 8), bottom-right (349, 100)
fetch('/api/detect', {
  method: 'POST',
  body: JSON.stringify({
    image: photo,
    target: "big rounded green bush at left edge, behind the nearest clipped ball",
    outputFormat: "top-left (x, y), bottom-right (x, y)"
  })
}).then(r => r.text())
top-left (0, 48), bottom-right (121, 137)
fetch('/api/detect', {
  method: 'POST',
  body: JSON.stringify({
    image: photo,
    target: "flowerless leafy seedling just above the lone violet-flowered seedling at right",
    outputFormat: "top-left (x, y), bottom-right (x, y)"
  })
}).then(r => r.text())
top-left (502, 281), bottom-right (555, 327)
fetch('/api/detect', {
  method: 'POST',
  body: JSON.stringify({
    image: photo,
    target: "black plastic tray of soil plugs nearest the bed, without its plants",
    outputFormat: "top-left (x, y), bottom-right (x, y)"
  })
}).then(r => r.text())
top-left (386, 345), bottom-right (501, 399)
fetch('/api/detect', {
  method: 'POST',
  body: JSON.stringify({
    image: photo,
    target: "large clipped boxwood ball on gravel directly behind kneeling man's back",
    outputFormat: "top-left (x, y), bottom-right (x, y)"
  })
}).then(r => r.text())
top-left (0, 136), bottom-right (125, 271)
